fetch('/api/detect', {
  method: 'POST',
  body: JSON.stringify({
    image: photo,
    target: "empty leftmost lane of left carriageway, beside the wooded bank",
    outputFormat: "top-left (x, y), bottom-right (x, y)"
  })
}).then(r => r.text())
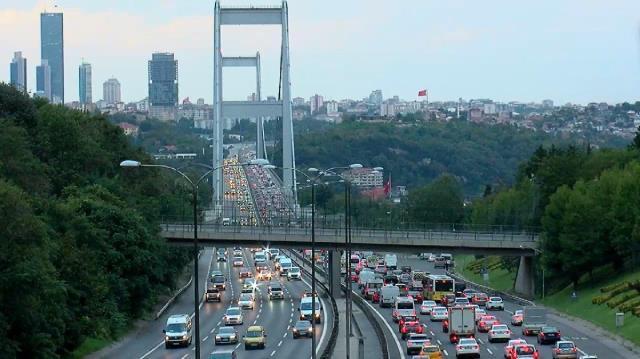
top-left (108, 250), bottom-right (213, 358)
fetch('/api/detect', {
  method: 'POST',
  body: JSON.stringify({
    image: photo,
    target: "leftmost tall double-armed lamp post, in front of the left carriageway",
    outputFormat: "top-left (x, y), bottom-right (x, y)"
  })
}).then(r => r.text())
top-left (120, 160), bottom-right (260, 359)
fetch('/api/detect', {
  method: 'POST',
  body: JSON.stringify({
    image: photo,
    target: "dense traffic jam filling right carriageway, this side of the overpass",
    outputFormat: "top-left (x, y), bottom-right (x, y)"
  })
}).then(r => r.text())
top-left (343, 252), bottom-right (596, 359)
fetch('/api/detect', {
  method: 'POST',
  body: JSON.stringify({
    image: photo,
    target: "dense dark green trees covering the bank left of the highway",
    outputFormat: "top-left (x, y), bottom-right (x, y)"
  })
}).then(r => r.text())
top-left (0, 84), bottom-right (189, 358)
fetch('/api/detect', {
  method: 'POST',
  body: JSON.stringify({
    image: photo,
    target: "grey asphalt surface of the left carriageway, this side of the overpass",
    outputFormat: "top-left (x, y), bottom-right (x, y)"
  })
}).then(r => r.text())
top-left (110, 248), bottom-right (330, 359)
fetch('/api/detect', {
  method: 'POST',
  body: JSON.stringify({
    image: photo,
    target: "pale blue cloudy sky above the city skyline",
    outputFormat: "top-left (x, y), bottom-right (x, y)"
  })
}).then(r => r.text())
top-left (0, 0), bottom-right (640, 104)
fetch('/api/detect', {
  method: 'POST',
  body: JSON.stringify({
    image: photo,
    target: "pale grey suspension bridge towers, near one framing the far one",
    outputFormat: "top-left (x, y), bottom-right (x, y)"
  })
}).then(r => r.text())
top-left (213, 0), bottom-right (297, 214)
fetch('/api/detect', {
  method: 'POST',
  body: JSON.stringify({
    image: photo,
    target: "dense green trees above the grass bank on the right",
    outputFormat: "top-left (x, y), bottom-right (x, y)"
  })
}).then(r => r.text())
top-left (470, 137), bottom-right (640, 292)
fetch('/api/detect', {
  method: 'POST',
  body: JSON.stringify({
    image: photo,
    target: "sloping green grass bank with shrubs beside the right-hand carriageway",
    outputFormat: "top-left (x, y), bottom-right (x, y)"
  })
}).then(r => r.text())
top-left (541, 270), bottom-right (640, 345)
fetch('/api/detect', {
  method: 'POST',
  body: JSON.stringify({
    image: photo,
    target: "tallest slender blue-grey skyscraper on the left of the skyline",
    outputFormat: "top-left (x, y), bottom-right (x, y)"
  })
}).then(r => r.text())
top-left (40, 12), bottom-right (64, 103)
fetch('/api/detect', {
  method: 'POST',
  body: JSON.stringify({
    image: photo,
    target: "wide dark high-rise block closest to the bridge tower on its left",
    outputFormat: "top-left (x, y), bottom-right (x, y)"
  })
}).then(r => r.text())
top-left (149, 53), bottom-right (178, 120)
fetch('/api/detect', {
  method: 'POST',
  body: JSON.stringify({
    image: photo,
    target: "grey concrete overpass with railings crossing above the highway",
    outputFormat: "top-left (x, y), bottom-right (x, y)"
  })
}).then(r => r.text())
top-left (160, 223), bottom-right (538, 296)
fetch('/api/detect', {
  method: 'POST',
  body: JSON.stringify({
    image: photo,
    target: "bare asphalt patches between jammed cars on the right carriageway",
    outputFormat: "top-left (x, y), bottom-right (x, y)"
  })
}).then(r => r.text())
top-left (360, 256), bottom-right (636, 359)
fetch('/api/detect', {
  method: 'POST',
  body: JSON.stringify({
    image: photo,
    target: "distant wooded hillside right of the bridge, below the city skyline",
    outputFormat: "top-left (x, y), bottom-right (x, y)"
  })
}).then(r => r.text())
top-left (284, 121), bottom-right (620, 196)
